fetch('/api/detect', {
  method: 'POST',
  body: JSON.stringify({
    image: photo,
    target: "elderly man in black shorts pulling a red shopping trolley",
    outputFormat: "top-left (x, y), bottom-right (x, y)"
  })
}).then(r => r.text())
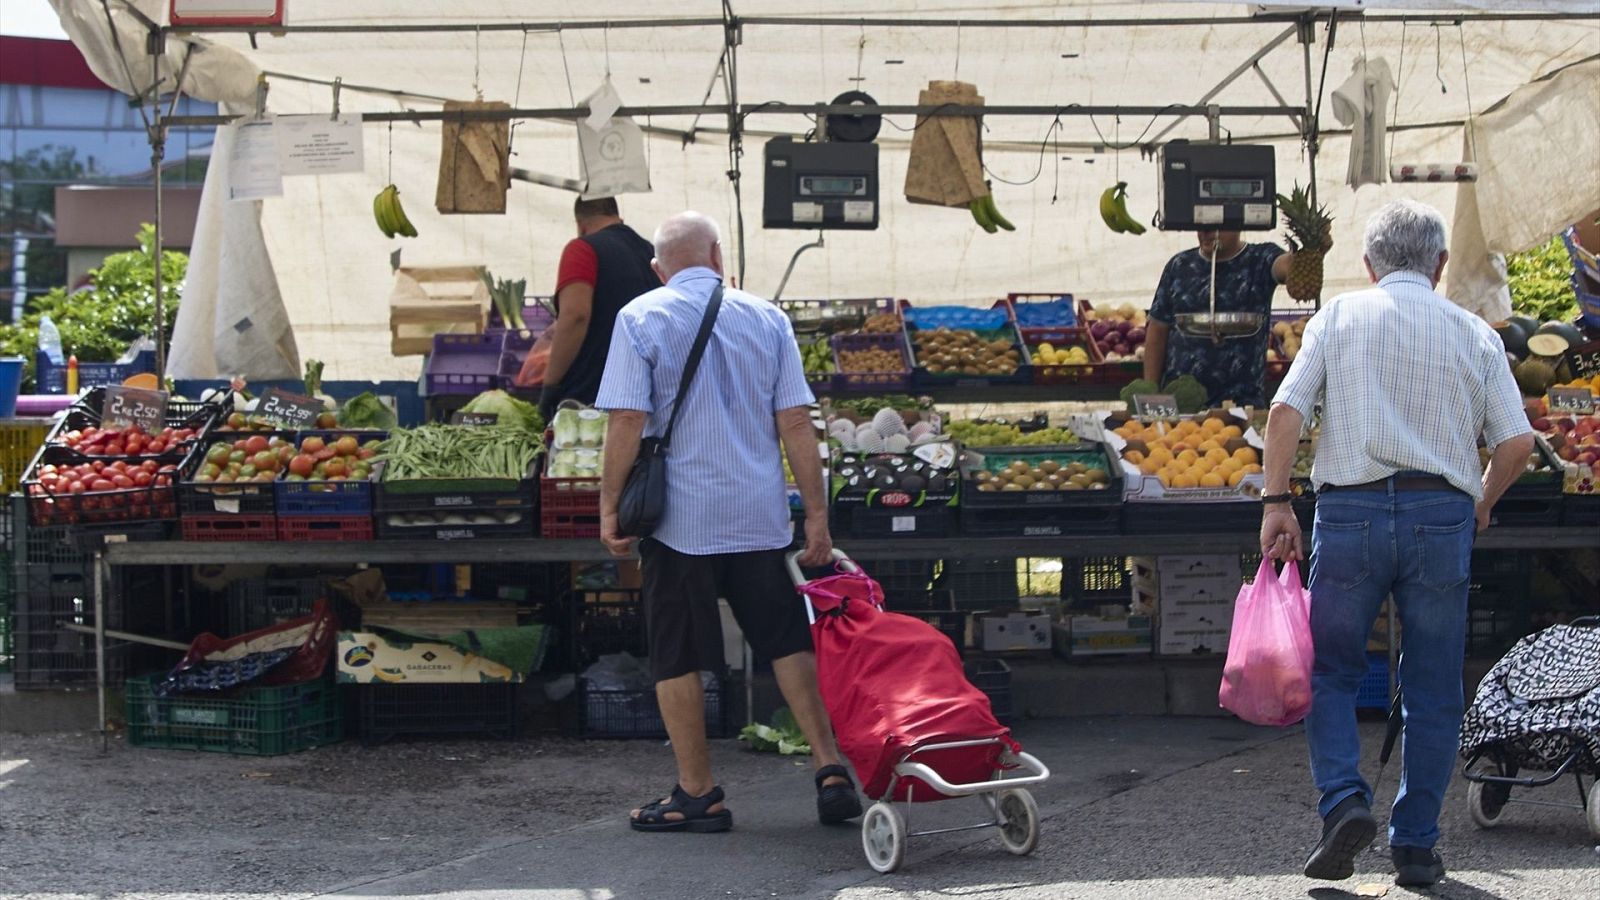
top-left (595, 213), bottom-right (861, 831)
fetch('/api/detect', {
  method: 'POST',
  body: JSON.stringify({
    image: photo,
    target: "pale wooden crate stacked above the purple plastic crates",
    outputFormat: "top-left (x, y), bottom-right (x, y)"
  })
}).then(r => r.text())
top-left (389, 266), bottom-right (490, 356)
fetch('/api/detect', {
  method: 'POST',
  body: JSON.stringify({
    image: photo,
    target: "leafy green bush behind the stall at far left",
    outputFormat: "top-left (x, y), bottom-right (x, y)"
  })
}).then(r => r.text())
top-left (0, 224), bottom-right (189, 392)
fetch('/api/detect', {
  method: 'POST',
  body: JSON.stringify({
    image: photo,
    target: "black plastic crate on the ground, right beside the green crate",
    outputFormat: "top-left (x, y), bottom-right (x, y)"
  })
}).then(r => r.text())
top-left (356, 684), bottom-right (518, 746)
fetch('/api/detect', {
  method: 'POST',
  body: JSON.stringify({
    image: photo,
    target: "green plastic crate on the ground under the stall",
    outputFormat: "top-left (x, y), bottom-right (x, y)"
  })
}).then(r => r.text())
top-left (125, 676), bottom-right (344, 756)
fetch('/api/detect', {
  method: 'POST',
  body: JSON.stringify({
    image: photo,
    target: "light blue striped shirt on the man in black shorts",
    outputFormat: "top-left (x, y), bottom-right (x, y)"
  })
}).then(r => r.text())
top-left (595, 267), bottom-right (814, 556)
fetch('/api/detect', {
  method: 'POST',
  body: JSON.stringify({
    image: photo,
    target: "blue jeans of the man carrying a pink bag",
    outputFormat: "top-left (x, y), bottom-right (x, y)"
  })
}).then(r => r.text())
top-left (1306, 482), bottom-right (1477, 847)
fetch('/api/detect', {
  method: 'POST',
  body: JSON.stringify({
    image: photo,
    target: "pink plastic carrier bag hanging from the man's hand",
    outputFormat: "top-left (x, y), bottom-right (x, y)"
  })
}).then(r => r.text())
top-left (1218, 557), bottom-right (1312, 725)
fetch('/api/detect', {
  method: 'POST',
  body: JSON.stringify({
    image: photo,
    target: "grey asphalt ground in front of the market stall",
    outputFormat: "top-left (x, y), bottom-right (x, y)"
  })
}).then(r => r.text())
top-left (0, 717), bottom-right (1600, 900)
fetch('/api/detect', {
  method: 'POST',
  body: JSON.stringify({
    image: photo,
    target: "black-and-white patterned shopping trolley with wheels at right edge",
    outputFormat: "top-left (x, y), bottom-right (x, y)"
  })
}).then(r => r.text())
top-left (1461, 617), bottom-right (1600, 841)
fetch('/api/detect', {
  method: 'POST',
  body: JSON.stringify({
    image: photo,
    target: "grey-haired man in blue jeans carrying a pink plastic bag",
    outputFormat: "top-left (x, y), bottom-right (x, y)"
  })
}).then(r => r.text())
top-left (1261, 200), bottom-right (1533, 886)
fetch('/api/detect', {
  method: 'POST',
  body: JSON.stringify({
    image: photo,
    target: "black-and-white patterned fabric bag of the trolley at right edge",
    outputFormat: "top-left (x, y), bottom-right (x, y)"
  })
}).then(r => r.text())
top-left (1461, 625), bottom-right (1600, 775)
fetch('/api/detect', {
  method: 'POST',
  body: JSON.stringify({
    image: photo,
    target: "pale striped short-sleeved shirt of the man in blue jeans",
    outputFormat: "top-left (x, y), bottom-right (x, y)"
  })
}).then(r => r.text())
top-left (1274, 272), bottom-right (1530, 500)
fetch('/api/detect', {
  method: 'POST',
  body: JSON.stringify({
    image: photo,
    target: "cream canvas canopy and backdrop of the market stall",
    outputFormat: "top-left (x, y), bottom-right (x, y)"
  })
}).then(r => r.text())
top-left (43, 0), bottom-right (1600, 378)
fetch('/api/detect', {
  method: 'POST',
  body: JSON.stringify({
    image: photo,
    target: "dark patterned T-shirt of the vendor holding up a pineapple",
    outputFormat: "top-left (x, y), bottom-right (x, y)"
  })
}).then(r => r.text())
top-left (1150, 243), bottom-right (1283, 407)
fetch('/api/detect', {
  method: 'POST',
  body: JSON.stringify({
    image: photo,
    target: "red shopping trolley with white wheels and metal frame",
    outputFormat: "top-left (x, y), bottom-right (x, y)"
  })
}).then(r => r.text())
top-left (789, 549), bottom-right (1050, 873)
